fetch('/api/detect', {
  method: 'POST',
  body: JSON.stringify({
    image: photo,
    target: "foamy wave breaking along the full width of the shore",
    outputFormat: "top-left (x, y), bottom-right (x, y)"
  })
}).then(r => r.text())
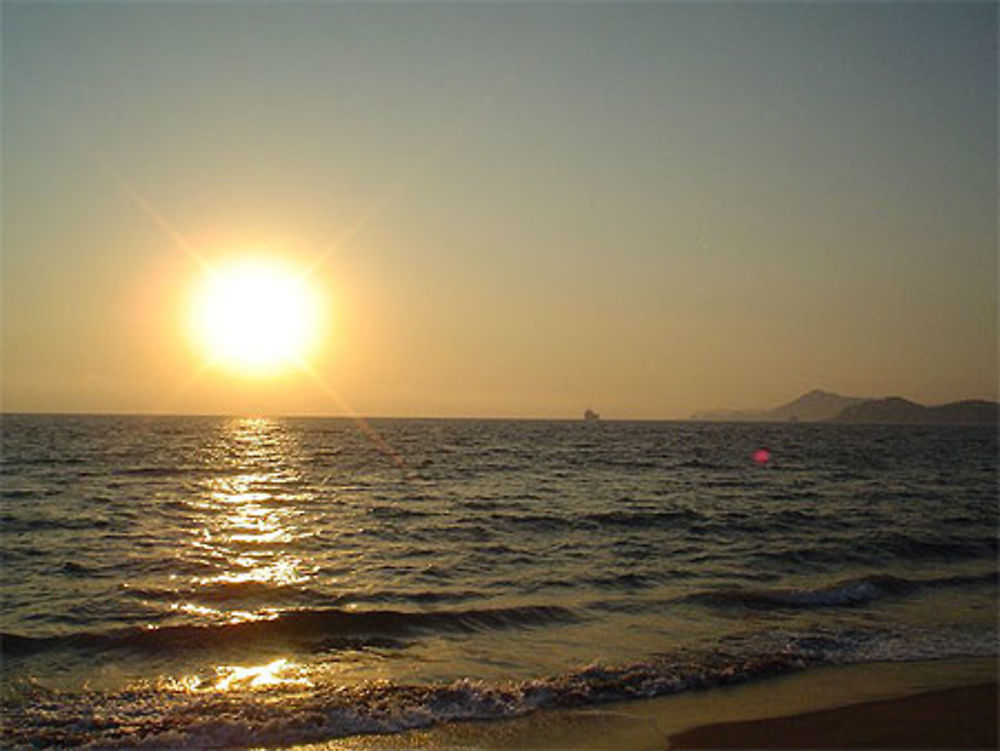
top-left (0, 629), bottom-right (997, 748)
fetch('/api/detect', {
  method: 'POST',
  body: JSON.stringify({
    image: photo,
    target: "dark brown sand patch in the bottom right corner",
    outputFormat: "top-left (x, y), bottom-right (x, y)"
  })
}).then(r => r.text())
top-left (669, 683), bottom-right (998, 749)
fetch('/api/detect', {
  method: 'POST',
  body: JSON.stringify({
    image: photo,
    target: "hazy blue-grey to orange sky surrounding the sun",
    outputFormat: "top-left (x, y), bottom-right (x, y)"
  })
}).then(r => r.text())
top-left (2, 2), bottom-right (998, 418)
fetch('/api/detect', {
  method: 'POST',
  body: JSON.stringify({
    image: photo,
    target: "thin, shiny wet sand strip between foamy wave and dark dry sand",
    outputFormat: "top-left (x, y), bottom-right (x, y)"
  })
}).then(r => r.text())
top-left (306, 657), bottom-right (998, 751)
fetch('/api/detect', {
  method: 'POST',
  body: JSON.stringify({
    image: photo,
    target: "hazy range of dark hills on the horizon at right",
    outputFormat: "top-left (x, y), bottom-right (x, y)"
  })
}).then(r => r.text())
top-left (691, 389), bottom-right (1000, 425)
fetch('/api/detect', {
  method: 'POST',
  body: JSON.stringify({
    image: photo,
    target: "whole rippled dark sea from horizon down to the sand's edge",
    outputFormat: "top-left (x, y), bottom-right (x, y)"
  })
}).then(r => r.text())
top-left (0, 415), bottom-right (998, 748)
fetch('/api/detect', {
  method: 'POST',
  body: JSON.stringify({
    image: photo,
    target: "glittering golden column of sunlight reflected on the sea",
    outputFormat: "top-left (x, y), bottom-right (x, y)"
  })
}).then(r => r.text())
top-left (152, 418), bottom-right (330, 693)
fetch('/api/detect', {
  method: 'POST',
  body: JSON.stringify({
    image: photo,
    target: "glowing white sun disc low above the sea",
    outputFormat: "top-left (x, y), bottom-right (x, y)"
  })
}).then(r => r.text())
top-left (191, 259), bottom-right (319, 376)
